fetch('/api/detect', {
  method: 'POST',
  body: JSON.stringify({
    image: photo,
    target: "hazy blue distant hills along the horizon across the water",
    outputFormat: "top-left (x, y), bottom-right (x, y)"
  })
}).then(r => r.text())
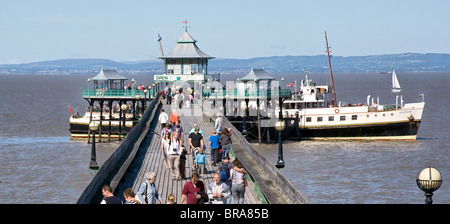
top-left (0, 53), bottom-right (450, 74)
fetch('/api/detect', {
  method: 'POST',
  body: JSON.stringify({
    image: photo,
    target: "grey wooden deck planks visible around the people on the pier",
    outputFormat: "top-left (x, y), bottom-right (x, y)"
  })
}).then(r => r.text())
top-left (115, 102), bottom-right (265, 204)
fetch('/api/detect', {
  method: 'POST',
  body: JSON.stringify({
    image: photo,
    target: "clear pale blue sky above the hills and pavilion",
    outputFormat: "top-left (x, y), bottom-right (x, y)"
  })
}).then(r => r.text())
top-left (0, 0), bottom-right (450, 64)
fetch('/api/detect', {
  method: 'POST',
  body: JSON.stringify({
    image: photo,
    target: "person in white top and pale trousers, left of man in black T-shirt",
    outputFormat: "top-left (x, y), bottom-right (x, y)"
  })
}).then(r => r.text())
top-left (167, 131), bottom-right (183, 180)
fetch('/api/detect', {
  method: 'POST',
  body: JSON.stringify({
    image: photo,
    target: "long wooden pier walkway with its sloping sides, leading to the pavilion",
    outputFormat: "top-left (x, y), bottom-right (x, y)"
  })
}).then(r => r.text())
top-left (78, 95), bottom-right (309, 204)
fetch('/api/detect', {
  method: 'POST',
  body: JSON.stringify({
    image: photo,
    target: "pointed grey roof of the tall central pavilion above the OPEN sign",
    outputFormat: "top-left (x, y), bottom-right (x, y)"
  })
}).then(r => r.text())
top-left (159, 32), bottom-right (214, 59)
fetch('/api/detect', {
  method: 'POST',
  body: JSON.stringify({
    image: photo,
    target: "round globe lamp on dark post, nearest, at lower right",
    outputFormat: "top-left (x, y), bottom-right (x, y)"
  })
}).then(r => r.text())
top-left (416, 166), bottom-right (442, 204)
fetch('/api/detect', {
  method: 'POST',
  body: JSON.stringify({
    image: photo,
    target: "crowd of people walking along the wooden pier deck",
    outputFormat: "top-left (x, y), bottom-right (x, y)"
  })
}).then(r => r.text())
top-left (102, 105), bottom-right (247, 204)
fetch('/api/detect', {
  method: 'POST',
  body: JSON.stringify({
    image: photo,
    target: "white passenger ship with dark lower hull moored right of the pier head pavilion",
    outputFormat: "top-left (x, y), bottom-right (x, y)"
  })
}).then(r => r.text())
top-left (275, 75), bottom-right (425, 140)
